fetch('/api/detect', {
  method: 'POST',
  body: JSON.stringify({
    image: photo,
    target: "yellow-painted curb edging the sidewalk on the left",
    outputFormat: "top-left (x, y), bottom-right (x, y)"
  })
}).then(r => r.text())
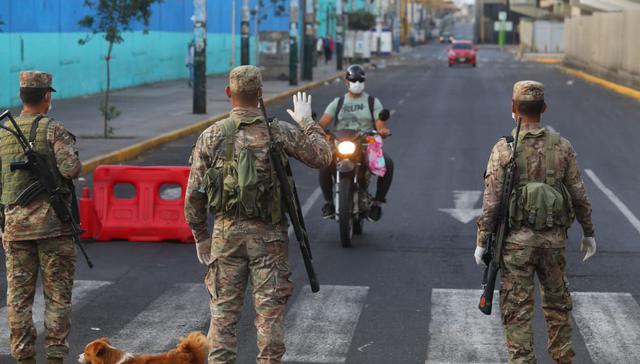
top-left (81, 72), bottom-right (343, 176)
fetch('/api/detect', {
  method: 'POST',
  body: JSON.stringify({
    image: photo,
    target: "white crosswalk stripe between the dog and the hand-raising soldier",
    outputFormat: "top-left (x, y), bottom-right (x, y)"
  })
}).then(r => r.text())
top-left (112, 283), bottom-right (211, 354)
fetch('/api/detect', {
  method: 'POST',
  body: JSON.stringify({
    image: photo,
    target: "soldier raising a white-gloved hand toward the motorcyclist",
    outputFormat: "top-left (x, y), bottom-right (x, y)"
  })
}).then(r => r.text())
top-left (185, 66), bottom-right (332, 364)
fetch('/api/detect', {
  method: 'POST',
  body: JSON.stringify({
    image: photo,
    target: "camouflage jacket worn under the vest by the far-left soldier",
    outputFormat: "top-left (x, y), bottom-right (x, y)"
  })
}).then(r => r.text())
top-left (0, 113), bottom-right (82, 241)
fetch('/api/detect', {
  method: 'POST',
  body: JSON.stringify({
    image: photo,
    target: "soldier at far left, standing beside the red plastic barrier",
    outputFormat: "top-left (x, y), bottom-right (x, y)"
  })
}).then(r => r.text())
top-left (0, 71), bottom-right (82, 364)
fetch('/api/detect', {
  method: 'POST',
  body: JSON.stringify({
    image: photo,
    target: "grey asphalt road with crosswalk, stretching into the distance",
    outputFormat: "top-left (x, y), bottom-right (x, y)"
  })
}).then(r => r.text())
top-left (0, 22), bottom-right (640, 364)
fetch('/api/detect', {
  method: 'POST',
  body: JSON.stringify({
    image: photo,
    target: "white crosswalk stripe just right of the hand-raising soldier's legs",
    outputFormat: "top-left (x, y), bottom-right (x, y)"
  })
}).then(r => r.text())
top-left (284, 286), bottom-right (369, 363)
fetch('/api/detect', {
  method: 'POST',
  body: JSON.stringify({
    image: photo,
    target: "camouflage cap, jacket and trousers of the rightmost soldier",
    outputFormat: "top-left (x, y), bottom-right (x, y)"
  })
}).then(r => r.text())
top-left (476, 81), bottom-right (594, 364)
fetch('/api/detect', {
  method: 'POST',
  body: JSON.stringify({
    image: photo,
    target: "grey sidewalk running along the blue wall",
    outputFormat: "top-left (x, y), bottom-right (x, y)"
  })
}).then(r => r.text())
top-left (7, 58), bottom-right (337, 172)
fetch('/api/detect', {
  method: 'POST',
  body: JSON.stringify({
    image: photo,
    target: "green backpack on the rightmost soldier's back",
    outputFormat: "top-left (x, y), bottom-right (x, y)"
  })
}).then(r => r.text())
top-left (509, 130), bottom-right (575, 231)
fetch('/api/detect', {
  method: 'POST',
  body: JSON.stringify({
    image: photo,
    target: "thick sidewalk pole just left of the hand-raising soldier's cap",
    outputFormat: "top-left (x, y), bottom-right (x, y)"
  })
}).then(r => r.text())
top-left (193, 0), bottom-right (207, 114)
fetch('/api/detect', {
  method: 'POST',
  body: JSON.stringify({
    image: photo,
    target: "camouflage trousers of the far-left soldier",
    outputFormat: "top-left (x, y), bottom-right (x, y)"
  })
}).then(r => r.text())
top-left (2, 236), bottom-right (76, 359)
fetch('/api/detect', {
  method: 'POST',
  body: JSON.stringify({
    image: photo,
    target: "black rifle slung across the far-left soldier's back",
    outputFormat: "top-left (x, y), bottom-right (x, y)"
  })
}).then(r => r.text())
top-left (0, 110), bottom-right (93, 268)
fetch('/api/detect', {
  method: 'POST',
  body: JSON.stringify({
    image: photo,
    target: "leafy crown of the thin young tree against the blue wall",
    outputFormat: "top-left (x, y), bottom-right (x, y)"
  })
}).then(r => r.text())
top-left (78, 0), bottom-right (164, 45)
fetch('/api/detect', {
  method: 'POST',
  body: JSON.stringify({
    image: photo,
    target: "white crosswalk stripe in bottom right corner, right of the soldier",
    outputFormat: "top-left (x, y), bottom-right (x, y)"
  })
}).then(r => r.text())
top-left (572, 292), bottom-right (640, 364)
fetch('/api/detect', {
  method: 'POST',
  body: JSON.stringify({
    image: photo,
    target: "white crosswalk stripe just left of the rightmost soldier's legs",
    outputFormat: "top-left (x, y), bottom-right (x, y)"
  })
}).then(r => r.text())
top-left (426, 289), bottom-right (508, 364)
